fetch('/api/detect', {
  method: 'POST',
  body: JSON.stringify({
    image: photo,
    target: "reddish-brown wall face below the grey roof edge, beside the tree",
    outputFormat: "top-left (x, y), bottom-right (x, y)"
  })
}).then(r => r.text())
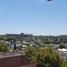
top-left (0, 56), bottom-right (35, 67)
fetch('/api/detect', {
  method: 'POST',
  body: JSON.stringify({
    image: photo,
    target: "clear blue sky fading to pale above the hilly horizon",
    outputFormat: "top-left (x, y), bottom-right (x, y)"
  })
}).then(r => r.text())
top-left (0, 0), bottom-right (67, 35)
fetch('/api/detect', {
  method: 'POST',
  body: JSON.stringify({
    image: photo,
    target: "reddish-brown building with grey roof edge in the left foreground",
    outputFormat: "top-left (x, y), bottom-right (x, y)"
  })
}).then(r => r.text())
top-left (0, 53), bottom-right (36, 67)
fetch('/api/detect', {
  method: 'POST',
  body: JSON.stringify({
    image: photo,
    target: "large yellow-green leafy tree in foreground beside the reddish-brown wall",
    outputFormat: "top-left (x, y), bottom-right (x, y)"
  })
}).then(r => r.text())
top-left (26, 47), bottom-right (63, 67)
